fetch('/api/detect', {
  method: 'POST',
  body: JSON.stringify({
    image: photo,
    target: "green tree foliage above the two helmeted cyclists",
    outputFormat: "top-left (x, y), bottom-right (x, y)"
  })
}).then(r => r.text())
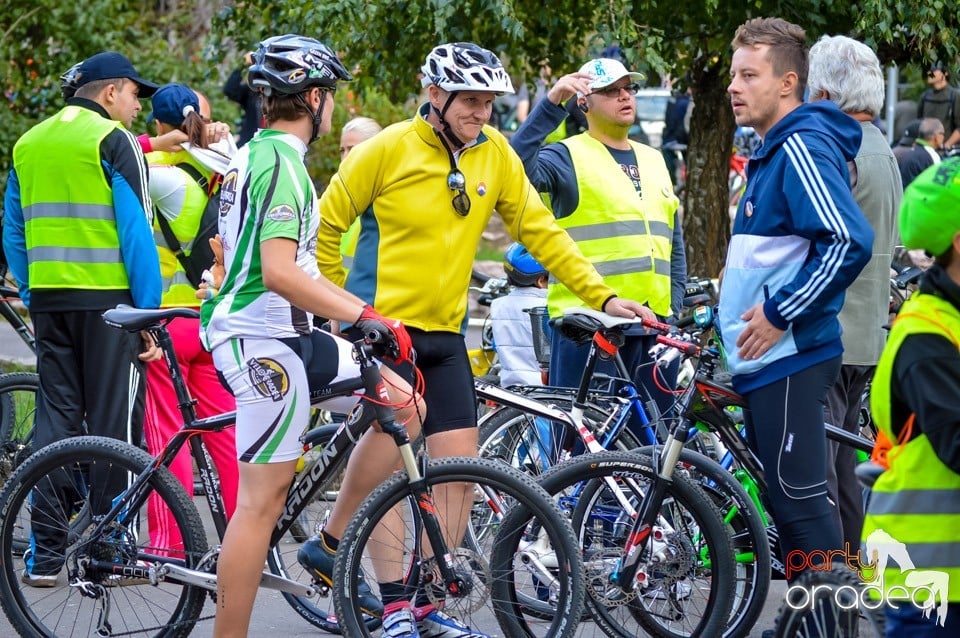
top-left (208, 0), bottom-right (604, 102)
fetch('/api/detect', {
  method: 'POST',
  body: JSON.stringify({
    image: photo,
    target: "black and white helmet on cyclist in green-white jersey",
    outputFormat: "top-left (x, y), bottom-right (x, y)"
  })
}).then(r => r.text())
top-left (247, 34), bottom-right (353, 95)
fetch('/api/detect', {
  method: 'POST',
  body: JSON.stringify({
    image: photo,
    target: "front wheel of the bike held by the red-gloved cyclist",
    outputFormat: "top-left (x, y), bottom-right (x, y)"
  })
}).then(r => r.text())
top-left (333, 457), bottom-right (584, 638)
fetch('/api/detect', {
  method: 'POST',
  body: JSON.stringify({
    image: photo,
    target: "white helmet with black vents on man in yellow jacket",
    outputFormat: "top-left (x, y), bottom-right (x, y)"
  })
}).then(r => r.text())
top-left (420, 42), bottom-right (514, 95)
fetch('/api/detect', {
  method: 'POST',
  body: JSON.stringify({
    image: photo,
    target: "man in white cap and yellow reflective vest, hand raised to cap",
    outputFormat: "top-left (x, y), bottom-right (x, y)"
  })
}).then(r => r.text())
top-left (510, 58), bottom-right (687, 426)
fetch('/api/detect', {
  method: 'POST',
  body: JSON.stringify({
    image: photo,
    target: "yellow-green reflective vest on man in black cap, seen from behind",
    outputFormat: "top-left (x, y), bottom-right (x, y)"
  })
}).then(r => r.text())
top-left (13, 106), bottom-right (130, 290)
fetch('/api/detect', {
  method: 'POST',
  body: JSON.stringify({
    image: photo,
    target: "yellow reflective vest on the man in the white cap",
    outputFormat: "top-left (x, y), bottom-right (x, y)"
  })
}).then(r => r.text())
top-left (547, 133), bottom-right (679, 317)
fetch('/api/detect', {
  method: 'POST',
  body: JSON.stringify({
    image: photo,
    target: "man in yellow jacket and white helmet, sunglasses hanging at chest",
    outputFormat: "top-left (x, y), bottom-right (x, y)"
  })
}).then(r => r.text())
top-left (308, 42), bottom-right (644, 638)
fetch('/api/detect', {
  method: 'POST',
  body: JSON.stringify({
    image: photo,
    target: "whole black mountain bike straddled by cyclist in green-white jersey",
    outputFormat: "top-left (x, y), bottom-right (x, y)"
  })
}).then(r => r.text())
top-left (0, 307), bottom-right (584, 636)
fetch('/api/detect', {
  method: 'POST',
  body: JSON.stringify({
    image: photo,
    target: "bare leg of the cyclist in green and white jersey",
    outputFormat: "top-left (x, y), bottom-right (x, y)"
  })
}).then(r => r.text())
top-left (213, 460), bottom-right (297, 638)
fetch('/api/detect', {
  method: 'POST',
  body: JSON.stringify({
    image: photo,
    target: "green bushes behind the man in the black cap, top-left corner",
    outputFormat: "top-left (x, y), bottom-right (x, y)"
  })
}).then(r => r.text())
top-left (0, 0), bottom-right (236, 198)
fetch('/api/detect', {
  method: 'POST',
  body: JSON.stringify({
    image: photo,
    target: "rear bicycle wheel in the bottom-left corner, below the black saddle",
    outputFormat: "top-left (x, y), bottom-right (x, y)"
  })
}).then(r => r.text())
top-left (0, 436), bottom-right (212, 637)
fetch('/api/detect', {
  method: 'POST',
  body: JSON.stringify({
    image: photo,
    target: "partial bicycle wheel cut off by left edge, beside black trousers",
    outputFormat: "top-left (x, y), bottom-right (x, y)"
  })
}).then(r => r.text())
top-left (0, 372), bottom-right (40, 485)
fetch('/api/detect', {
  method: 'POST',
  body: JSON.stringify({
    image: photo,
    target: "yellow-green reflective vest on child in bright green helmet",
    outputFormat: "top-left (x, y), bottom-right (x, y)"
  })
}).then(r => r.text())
top-left (862, 293), bottom-right (960, 604)
